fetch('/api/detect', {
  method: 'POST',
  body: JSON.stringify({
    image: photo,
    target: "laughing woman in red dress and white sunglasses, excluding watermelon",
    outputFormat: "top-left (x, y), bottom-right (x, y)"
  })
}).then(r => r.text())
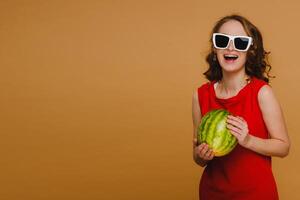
top-left (192, 15), bottom-right (290, 200)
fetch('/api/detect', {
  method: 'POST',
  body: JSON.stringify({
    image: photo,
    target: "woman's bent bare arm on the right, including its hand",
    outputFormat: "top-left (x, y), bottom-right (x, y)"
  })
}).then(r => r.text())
top-left (228, 85), bottom-right (290, 157)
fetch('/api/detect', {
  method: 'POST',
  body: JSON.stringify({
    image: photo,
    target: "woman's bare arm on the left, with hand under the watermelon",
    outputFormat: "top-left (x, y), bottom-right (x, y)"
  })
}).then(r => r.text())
top-left (192, 90), bottom-right (214, 167)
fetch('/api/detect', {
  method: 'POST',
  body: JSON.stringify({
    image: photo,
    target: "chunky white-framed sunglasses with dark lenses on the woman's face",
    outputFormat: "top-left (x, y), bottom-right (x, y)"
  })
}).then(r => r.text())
top-left (212, 33), bottom-right (253, 51)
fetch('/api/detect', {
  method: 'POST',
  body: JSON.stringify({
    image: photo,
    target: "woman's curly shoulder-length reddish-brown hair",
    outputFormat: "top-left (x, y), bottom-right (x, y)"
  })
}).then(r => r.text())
top-left (203, 14), bottom-right (274, 82)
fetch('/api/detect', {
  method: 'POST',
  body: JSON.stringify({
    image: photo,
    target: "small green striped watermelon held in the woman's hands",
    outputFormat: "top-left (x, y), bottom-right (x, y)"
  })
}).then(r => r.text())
top-left (197, 109), bottom-right (237, 156)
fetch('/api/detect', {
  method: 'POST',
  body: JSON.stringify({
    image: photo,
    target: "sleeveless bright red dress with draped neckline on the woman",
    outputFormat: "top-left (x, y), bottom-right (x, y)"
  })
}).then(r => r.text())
top-left (198, 77), bottom-right (278, 200)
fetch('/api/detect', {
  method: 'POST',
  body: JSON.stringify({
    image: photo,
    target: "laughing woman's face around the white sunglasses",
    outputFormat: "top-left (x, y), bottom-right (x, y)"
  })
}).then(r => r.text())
top-left (214, 20), bottom-right (248, 72)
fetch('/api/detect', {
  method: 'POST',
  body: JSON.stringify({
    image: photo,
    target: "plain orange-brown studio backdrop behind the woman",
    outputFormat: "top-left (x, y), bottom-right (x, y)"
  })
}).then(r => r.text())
top-left (0, 0), bottom-right (300, 200)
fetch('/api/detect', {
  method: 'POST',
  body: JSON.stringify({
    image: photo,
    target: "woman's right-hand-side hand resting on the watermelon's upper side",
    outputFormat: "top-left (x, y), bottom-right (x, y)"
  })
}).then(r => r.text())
top-left (227, 115), bottom-right (250, 147)
